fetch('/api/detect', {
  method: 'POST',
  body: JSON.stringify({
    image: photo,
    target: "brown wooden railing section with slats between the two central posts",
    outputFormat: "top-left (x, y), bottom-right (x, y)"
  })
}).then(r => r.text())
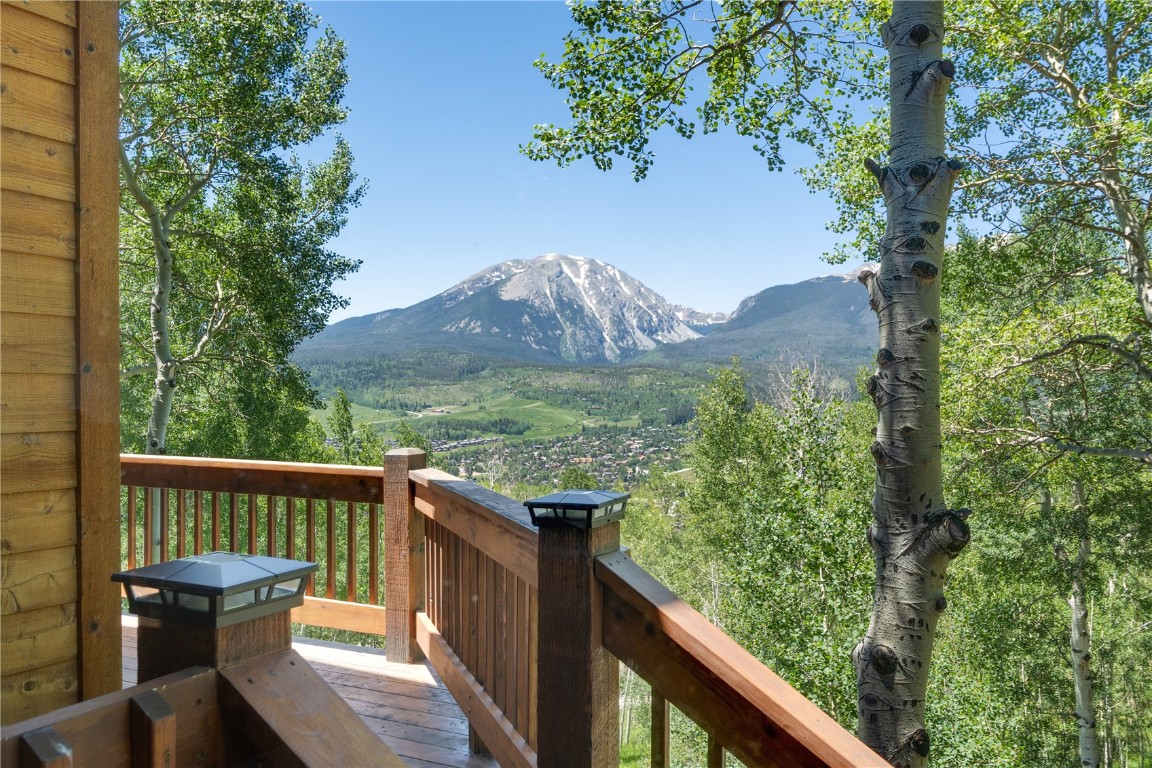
top-left (403, 465), bottom-right (539, 767)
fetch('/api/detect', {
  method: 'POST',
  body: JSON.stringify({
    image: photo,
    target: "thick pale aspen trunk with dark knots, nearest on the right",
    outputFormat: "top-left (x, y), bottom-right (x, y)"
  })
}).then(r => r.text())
top-left (852, 0), bottom-right (969, 768)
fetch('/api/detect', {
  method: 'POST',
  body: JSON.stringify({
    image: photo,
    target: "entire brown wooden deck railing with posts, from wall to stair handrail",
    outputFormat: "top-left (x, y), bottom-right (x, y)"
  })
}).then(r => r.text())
top-left (122, 449), bottom-right (886, 768)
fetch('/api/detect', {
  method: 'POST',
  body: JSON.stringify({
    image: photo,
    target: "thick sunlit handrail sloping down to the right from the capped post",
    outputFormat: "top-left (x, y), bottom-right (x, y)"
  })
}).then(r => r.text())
top-left (596, 553), bottom-right (888, 768)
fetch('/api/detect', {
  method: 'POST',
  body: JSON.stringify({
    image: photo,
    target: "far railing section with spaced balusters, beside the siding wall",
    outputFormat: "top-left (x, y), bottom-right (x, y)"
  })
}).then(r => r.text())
top-left (120, 454), bottom-right (386, 634)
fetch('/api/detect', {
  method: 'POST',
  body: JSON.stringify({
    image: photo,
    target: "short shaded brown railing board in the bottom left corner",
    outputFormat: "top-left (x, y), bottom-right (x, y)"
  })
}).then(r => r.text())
top-left (0, 667), bottom-right (218, 768)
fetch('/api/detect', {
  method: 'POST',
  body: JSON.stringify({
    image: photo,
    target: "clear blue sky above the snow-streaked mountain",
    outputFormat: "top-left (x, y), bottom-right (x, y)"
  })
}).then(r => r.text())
top-left (311, 0), bottom-right (858, 321)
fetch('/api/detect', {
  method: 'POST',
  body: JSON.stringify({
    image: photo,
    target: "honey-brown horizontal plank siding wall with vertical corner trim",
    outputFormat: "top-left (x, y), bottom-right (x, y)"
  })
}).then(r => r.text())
top-left (0, 0), bottom-right (120, 723)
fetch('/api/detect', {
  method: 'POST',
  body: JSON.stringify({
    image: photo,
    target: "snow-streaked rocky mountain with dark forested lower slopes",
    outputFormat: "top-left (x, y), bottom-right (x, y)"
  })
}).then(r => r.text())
top-left (296, 253), bottom-right (876, 375)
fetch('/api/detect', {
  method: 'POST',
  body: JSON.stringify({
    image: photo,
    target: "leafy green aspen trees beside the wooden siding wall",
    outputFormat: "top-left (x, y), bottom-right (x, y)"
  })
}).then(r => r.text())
top-left (120, 0), bottom-right (363, 455)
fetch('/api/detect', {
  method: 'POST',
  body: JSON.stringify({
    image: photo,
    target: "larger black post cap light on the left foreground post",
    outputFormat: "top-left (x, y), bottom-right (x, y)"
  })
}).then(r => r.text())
top-left (112, 552), bottom-right (316, 628)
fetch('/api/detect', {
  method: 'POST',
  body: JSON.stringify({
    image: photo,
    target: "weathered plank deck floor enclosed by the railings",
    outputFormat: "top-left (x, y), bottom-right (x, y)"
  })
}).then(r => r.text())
top-left (122, 615), bottom-right (497, 768)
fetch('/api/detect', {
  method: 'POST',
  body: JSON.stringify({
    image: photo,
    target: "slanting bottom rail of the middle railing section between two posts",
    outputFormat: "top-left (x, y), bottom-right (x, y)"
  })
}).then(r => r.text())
top-left (417, 613), bottom-right (537, 768)
